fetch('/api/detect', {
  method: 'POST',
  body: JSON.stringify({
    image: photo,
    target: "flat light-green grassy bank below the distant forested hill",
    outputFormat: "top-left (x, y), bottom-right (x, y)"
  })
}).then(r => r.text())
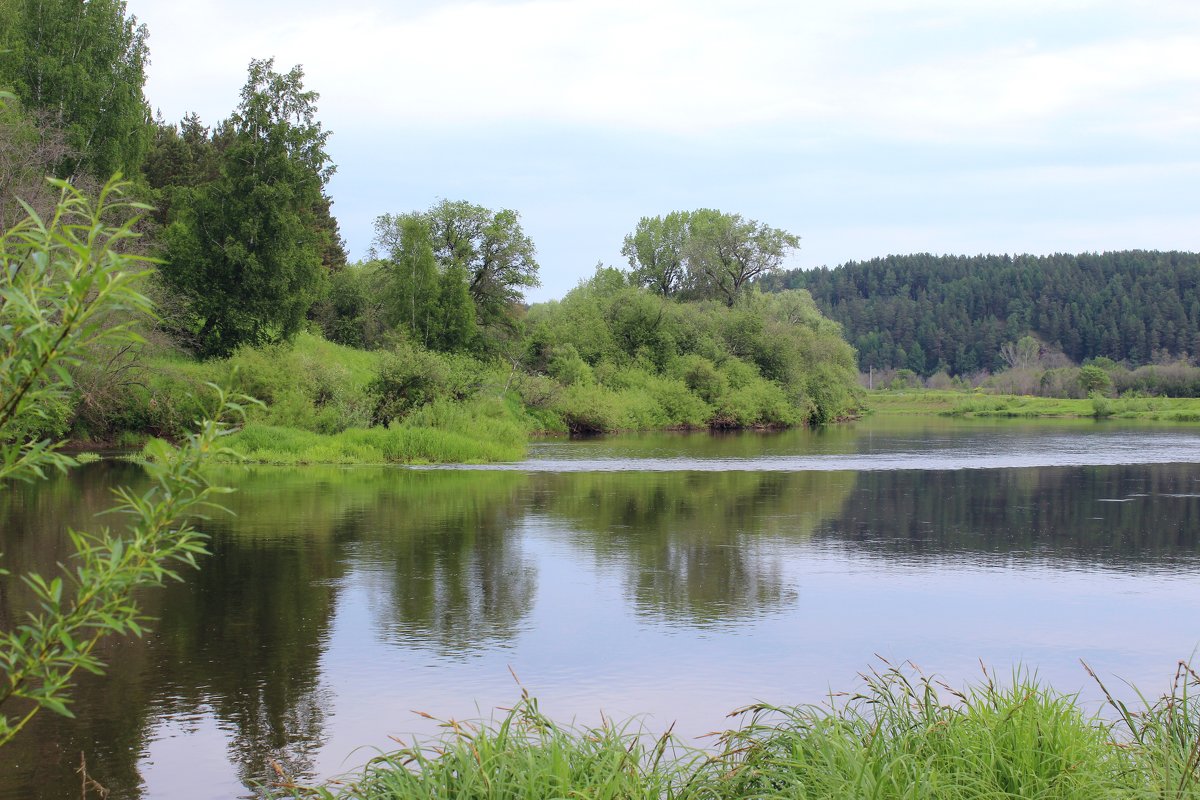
top-left (864, 390), bottom-right (1200, 422)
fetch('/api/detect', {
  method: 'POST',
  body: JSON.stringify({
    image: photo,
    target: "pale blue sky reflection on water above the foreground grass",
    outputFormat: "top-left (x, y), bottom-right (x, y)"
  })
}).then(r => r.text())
top-left (297, 510), bottom-right (1200, 786)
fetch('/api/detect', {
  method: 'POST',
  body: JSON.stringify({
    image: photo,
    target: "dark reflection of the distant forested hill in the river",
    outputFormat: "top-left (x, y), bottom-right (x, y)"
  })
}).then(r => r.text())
top-left (822, 464), bottom-right (1200, 567)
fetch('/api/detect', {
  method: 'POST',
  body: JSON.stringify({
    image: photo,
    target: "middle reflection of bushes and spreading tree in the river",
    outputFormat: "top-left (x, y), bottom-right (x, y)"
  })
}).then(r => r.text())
top-left (538, 471), bottom-right (854, 626)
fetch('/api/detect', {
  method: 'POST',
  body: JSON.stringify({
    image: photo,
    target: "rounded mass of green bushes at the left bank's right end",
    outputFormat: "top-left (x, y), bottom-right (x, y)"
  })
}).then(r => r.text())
top-left (526, 278), bottom-right (857, 433)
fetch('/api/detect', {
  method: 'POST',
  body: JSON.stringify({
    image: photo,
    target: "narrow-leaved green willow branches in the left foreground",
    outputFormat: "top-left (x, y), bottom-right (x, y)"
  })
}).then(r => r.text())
top-left (0, 181), bottom-right (241, 746)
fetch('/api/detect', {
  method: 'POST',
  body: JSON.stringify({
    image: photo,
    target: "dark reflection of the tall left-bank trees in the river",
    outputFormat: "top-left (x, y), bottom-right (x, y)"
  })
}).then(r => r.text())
top-left (0, 464), bottom-right (536, 798)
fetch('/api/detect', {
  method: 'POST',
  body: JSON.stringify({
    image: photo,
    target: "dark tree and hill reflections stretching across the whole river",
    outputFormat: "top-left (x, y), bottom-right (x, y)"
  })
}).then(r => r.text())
top-left (14, 453), bottom-right (1200, 798)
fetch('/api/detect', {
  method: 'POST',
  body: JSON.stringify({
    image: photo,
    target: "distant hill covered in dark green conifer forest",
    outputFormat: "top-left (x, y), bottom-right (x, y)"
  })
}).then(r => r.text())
top-left (761, 251), bottom-right (1200, 375)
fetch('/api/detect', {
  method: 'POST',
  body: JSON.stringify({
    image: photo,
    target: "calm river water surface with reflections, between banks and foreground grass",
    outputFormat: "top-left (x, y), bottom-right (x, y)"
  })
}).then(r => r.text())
top-left (0, 420), bottom-right (1200, 800)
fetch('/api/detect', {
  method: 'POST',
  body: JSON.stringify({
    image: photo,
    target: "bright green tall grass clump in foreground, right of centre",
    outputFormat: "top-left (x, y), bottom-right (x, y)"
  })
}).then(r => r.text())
top-left (709, 668), bottom-right (1132, 800)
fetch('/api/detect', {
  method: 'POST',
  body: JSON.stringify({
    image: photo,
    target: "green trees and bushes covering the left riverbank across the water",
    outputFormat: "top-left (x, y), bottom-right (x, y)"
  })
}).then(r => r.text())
top-left (0, 0), bottom-right (857, 462)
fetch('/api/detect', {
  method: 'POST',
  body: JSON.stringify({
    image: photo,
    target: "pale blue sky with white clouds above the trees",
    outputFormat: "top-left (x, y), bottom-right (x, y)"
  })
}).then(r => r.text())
top-left (128, 0), bottom-right (1200, 301)
